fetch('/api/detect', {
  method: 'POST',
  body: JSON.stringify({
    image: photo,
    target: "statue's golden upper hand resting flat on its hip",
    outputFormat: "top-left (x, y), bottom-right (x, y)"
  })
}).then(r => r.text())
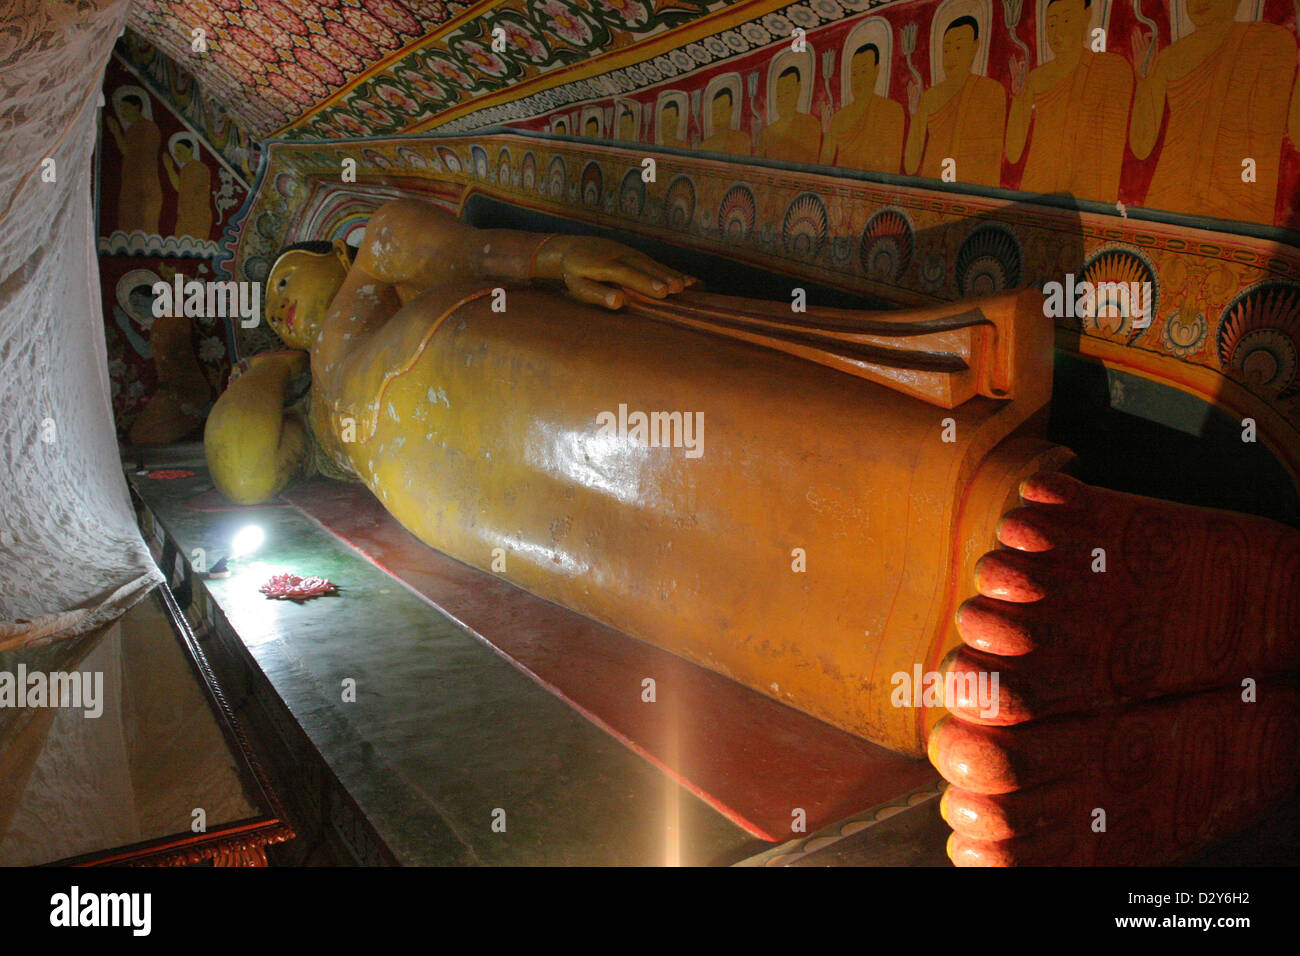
top-left (537, 235), bottom-right (696, 308)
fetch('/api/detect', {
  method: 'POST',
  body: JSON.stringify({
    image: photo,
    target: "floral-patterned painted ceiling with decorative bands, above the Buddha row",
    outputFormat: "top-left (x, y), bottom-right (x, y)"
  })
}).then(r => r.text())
top-left (122, 0), bottom-right (888, 139)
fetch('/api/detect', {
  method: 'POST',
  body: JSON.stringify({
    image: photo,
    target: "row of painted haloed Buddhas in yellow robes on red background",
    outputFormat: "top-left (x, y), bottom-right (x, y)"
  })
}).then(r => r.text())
top-left (551, 0), bottom-right (1300, 224)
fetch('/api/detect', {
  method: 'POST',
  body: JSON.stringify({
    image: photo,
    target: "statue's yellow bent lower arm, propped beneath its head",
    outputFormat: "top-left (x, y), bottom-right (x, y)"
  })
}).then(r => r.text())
top-left (203, 351), bottom-right (307, 505)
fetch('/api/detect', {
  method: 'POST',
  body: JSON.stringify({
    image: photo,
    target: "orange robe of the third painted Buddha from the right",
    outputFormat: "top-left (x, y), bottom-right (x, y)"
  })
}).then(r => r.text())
top-left (920, 73), bottom-right (1006, 186)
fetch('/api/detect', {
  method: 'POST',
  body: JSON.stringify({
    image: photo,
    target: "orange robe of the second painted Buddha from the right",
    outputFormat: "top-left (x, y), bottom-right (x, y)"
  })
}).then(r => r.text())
top-left (1019, 51), bottom-right (1134, 203)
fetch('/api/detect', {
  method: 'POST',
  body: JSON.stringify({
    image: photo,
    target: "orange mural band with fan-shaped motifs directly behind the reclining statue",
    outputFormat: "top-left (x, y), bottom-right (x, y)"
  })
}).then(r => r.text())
top-left (234, 134), bottom-right (1300, 484)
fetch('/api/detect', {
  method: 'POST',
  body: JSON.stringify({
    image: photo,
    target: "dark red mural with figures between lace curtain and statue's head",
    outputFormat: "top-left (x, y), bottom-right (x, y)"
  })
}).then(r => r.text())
top-left (96, 59), bottom-right (248, 441)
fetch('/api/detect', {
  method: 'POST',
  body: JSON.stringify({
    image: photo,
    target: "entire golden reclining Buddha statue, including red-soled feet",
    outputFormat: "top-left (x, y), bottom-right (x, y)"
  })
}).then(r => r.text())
top-left (205, 199), bottom-right (1300, 864)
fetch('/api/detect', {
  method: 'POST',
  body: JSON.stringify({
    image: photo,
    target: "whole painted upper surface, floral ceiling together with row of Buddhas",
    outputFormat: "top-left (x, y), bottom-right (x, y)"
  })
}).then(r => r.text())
top-left (122, 0), bottom-right (1300, 228)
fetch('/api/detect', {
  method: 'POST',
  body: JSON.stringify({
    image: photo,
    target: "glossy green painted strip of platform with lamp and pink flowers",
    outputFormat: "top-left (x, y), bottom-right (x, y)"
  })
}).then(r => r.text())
top-left (129, 472), bottom-right (770, 865)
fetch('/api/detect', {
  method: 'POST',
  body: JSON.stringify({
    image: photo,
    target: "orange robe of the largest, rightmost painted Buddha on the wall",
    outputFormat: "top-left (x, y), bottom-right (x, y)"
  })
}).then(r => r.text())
top-left (1143, 23), bottom-right (1296, 224)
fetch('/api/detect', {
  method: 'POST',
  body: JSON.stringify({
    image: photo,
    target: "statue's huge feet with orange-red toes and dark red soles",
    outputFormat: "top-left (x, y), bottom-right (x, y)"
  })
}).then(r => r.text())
top-left (930, 473), bottom-right (1300, 865)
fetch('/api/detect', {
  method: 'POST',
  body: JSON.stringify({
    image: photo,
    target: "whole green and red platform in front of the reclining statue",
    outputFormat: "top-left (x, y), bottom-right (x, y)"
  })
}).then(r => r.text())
top-left (127, 447), bottom-right (948, 865)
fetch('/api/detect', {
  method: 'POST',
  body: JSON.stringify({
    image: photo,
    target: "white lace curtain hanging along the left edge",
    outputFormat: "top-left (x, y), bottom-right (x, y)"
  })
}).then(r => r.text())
top-left (0, 0), bottom-right (163, 650)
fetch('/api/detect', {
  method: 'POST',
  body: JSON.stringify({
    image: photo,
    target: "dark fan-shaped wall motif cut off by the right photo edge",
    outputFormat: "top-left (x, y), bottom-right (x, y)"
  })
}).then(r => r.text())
top-left (1218, 281), bottom-right (1300, 398)
